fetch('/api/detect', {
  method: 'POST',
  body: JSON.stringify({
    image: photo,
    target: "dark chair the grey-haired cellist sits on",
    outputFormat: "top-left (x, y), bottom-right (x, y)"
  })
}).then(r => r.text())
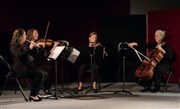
top-left (162, 53), bottom-right (180, 92)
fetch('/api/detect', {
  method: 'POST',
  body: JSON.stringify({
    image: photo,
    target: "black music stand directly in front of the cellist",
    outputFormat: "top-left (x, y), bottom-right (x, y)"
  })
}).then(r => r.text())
top-left (114, 43), bottom-right (132, 95)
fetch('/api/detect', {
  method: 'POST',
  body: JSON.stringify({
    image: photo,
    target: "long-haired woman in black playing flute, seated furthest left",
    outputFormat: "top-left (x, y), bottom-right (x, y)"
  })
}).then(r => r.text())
top-left (10, 28), bottom-right (47, 101)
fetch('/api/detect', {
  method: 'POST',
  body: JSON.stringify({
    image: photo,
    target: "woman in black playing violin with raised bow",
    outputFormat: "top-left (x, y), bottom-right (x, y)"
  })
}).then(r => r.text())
top-left (27, 28), bottom-right (58, 94)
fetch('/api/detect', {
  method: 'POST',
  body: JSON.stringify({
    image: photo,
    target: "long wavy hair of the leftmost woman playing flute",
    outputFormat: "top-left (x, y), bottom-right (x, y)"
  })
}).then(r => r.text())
top-left (11, 28), bottom-right (25, 43)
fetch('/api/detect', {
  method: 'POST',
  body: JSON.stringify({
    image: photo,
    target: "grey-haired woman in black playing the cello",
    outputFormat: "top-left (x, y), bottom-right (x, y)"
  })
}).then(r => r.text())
top-left (128, 30), bottom-right (173, 92)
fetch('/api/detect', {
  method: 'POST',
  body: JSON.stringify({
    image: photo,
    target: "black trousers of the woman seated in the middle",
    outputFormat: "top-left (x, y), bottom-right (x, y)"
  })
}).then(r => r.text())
top-left (78, 63), bottom-right (99, 82)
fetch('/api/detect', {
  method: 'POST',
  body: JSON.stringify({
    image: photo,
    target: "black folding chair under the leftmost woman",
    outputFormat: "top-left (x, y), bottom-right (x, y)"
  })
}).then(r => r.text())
top-left (0, 55), bottom-right (28, 102)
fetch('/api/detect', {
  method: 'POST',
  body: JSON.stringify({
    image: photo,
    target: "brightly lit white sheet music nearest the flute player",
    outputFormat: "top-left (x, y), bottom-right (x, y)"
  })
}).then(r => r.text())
top-left (48, 46), bottom-right (65, 60)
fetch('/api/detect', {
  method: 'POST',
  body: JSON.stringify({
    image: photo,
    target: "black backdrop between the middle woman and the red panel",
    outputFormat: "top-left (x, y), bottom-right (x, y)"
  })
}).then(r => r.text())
top-left (100, 15), bottom-right (146, 81)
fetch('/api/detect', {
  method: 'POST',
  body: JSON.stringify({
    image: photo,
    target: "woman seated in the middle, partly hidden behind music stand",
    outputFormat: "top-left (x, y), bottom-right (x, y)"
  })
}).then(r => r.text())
top-left (75, 32), bottom-right (107, 94)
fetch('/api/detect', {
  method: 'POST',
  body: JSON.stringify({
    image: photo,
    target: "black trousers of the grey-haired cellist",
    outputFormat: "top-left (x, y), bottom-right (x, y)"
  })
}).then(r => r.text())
top-left (145, 65), bottom-right (170, 88)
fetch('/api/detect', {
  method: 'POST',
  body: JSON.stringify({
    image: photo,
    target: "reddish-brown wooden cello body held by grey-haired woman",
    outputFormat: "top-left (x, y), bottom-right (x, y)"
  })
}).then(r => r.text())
top-left (135, 49), bottom-right (164, 80)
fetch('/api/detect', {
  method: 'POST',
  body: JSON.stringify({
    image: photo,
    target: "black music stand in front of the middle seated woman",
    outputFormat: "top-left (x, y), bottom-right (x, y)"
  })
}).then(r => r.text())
top-left (80, 47), bottom-right (105, 94)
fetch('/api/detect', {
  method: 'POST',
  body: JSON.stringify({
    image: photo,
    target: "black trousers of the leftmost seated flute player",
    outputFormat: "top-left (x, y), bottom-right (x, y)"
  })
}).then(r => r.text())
top-left (27, 68), bottom-right (48, 96)
